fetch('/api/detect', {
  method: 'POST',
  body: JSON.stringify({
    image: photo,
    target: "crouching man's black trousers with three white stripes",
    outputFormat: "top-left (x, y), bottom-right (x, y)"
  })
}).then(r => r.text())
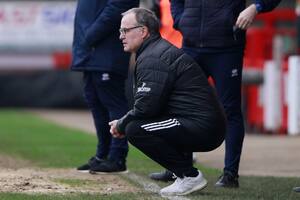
top-left (125, 117), bottom-right (224, 177)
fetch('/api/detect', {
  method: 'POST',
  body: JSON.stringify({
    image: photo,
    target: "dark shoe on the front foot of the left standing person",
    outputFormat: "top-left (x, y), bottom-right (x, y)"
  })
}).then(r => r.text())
top-left (90, 160), bottom-right (128, 174)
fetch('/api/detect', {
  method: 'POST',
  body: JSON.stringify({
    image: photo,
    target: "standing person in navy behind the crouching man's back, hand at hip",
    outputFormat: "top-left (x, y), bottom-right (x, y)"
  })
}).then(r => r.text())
top-left (150, 0), bottom-right (280, 188)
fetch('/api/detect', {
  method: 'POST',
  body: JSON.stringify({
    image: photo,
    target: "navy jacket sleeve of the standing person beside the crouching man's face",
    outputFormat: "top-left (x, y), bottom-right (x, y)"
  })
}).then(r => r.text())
top-left (85, 0), bottom-right (139, 46)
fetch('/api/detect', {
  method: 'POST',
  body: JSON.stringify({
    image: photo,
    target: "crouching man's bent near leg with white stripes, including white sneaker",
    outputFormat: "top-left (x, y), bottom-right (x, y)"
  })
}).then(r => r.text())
top-left (125, 118), bottom-right (209, 195)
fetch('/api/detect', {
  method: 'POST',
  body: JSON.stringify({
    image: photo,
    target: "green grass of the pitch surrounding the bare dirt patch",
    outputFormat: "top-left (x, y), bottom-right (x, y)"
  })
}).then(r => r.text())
top-left (0, 110), bottom-right (300, 200)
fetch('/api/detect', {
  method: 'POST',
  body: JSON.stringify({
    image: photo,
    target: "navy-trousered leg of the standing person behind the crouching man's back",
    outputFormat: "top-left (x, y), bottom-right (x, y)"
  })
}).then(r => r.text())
top-left (198, 49), bottom-right (245, 187)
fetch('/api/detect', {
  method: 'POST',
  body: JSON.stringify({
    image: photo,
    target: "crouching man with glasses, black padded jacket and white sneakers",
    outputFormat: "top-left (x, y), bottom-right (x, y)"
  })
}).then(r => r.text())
top-left (110, 8), bottom-right (226, 196)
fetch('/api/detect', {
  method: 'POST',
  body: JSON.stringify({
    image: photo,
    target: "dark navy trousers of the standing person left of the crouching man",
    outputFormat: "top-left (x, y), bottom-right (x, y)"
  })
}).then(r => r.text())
top-left (84, 72), bottom-right (128, 162)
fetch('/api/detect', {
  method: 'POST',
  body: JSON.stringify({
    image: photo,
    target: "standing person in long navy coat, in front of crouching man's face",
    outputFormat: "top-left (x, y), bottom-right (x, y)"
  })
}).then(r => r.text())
top-left (71, 0), bottom-right (139, 173)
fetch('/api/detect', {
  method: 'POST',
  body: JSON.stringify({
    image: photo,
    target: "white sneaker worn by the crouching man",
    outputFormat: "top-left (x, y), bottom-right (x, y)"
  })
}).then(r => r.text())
top-left (160, 171), bottom-right (207, 196)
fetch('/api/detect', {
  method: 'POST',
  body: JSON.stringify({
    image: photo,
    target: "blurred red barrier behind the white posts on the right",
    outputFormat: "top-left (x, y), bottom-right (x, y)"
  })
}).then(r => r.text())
top-left (243, 9), bottom-right (296, 133)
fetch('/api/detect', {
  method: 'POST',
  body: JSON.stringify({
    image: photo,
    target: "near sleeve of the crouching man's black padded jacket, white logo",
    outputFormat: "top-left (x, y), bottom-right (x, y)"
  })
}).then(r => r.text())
top-left (117, 58), bottom-right (171, 134)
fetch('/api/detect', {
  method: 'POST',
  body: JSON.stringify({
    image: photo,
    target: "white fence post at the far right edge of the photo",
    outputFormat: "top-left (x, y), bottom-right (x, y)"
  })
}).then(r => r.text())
top-left (288, 56), bottom-right (300, 135)
